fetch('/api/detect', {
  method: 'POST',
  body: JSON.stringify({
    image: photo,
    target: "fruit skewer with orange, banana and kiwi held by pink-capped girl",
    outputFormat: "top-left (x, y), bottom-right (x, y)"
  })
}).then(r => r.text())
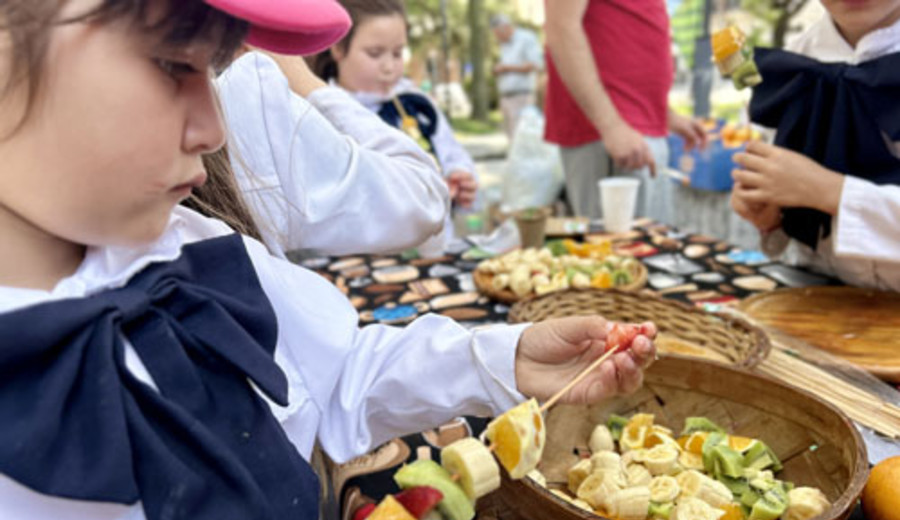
top-left (354, 324), bottom-right (644, 520)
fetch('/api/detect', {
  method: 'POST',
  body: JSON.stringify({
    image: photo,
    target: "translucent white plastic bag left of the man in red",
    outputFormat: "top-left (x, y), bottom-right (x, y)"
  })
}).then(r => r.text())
top-left (502, 106), bottom-right (563, 212)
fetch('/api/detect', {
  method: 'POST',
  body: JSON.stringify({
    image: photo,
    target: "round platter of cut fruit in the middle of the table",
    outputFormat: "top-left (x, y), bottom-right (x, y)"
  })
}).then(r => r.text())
top-left (473, 239), bottom-right (647, 303)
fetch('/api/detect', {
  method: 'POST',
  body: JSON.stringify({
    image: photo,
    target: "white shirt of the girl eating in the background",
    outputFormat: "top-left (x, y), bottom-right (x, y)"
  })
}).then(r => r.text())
top-left (338, 78), bottom-right (477, 179)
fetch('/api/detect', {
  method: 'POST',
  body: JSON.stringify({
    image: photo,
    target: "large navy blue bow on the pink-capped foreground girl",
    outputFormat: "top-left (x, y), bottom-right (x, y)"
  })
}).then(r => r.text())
top-left (0, 235), bottom-right (318, 520)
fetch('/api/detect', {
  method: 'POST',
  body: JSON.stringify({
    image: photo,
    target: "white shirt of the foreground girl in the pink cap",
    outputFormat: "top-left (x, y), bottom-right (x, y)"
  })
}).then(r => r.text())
top-left (0, 206), bottom-right (524, 520)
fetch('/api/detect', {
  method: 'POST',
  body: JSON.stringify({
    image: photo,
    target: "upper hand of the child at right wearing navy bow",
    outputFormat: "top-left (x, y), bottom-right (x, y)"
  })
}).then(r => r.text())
top-left (732, 141), bottom-right (844, 215)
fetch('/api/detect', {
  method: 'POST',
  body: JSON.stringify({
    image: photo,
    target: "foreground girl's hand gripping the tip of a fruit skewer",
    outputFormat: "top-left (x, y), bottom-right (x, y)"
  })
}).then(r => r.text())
top-left (516, 316), bottom-right (656, 403)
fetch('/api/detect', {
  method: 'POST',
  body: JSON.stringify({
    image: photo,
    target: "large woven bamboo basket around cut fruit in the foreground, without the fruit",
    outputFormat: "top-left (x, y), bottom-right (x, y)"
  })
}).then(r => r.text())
top-left (479, 357), bottom-right (868, 520)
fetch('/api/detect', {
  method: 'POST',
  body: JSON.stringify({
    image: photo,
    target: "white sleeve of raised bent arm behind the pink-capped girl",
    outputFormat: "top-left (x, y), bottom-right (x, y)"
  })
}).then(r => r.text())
top-left (216, 52), bottom-right (449, 255)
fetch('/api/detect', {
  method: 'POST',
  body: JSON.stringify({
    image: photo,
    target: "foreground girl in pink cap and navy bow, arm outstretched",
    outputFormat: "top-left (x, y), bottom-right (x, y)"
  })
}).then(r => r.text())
top-left (0, 0), bottom-right (655, 520)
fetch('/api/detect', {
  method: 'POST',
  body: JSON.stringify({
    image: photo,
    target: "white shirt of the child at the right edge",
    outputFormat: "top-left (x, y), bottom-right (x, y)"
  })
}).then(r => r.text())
top-left (762, 15), bottom-right (900, 291)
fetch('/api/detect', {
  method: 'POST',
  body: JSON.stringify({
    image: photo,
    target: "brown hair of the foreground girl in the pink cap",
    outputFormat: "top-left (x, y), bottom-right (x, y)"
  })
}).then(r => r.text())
top-left (0, 0), bottom-right (261, 244)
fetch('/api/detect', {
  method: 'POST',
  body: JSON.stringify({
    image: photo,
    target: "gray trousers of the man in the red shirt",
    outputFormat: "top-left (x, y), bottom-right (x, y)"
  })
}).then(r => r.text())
top-left (560, 137), bottom-right (674, 223)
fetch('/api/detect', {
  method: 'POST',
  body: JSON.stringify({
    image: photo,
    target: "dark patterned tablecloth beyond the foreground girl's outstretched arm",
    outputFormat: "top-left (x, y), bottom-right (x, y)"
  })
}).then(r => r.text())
top-left (299, 221), bottom-right (837, 326)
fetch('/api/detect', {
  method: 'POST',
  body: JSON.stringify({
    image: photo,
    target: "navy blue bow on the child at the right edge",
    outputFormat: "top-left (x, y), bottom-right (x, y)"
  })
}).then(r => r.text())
top-left (750, 49), bottom-right (900, 249)
